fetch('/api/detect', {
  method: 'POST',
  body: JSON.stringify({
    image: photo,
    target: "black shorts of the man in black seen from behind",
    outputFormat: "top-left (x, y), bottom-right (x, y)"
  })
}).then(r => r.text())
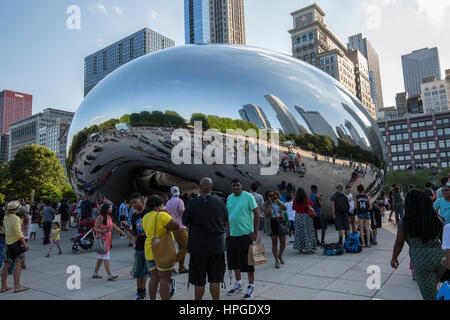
top-left (189, 253), bottom-right (226, 287)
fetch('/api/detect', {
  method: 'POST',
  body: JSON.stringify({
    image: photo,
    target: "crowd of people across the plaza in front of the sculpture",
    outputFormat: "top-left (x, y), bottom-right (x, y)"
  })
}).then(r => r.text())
top-left (0, 174), bottom-right (450, 300)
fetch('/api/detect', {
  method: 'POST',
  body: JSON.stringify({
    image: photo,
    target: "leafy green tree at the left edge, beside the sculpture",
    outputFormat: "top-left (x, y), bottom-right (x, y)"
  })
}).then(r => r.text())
top-left (0, 144), bottom-right (66, 199)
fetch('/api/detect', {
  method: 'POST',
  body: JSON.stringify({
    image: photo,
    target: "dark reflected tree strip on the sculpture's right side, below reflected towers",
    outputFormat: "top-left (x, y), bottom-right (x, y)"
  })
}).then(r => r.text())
top-left (280, 133), bottom-right (380, 167)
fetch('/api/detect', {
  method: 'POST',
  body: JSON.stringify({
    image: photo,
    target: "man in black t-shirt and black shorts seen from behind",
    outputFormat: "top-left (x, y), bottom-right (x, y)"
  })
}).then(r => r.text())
top-left (183, 178), bottom-right (228, 300)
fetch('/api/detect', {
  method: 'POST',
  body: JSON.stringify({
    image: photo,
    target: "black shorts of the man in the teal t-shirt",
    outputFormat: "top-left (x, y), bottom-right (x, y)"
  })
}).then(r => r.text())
top-left (227, 235), bottom-right (255, 272)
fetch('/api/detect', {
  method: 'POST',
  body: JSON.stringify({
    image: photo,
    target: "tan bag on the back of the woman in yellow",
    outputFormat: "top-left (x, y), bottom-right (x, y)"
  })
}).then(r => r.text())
top-left (152, 212), bottom-right (176, 268)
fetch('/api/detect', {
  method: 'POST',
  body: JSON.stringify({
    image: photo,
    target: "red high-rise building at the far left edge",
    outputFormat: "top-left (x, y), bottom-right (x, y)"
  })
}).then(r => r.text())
top-left (0, 90), bottom-right (33, 134)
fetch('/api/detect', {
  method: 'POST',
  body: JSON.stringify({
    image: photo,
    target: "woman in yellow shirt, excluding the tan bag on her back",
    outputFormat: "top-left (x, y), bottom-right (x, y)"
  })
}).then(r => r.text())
top-left (142, 195), bottom-right (179, 300)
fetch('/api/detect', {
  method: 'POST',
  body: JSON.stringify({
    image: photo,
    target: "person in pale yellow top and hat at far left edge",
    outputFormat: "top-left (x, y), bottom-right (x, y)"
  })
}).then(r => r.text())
top-left (0, 201), bottom-right (30, 293)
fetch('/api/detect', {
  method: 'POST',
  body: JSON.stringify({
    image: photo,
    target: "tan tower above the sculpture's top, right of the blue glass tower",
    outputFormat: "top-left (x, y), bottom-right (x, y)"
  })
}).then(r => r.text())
top-left (209, 0), bottom-right (245, 44)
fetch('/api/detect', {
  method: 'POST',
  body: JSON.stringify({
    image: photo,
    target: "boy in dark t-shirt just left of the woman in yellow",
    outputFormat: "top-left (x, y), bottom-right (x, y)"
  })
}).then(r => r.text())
top-left (122, 193), bottom-right (149, 300)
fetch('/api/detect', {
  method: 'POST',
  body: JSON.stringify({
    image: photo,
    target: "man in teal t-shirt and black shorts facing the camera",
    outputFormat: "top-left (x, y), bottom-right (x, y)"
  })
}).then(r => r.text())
top-left (227, 179), bottom-right (259, 300)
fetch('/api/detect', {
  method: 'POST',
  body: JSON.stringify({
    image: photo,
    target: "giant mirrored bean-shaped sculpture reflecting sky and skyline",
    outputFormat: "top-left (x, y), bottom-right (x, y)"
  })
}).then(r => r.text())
top-left (67, 45), bottom-right (385, 217)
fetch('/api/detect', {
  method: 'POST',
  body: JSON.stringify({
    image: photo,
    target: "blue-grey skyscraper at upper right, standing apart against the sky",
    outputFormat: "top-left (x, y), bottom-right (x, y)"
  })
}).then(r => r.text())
top-left (402, 48), bottom-right (441, 96)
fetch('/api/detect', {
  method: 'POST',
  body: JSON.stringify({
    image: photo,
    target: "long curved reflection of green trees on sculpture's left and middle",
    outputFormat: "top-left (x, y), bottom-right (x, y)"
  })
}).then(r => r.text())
top-left (66, 110), bottom-right (259, 176)
